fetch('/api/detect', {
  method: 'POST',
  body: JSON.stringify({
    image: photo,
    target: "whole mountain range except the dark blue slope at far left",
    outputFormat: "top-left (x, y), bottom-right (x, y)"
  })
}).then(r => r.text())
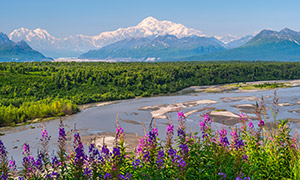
top-left (4, 17), bottom-right (300, 61)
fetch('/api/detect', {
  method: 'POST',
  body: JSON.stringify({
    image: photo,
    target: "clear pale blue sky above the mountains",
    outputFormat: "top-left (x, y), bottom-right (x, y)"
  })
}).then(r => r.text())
top-left (0, 0), bottom-right (300, 37)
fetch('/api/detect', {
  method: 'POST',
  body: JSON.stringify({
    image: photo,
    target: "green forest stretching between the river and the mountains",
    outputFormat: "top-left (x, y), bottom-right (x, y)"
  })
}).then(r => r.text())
top-left (0, 61), bottom-right (300, 126)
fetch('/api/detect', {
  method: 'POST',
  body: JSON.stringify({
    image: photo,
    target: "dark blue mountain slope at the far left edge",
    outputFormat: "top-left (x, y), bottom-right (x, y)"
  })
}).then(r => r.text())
top-left (0, 32), bottom-right (49, 61)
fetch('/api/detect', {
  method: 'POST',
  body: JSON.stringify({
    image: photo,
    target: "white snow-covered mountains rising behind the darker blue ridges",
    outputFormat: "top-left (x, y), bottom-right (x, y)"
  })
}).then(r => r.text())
top-left (9, 17), bottom-right (250, 58)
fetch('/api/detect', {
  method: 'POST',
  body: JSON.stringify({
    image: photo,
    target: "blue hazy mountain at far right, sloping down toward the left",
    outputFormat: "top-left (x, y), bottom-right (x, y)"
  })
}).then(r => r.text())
top-left (185, 28), bottom-right (300, 61)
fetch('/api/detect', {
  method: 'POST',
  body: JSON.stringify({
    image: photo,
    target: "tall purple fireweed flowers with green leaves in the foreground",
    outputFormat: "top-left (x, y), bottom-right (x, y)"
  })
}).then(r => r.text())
top-left (0, 109), bottom-right (300, 180)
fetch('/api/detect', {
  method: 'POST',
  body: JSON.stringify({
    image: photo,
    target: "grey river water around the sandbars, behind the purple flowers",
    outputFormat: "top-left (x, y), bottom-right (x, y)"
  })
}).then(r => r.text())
top-left (0, 87), bottom-right (300, 165)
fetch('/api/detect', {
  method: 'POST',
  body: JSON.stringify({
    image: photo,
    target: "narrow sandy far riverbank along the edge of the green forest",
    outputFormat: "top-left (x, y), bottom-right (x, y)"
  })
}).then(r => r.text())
top-left (0, 79), bottom-right (300, 131)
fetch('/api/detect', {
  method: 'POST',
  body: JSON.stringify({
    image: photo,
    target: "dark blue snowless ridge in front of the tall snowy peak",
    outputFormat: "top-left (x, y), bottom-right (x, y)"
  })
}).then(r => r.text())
top-left (80, 34), bottom-right (225, 60)
